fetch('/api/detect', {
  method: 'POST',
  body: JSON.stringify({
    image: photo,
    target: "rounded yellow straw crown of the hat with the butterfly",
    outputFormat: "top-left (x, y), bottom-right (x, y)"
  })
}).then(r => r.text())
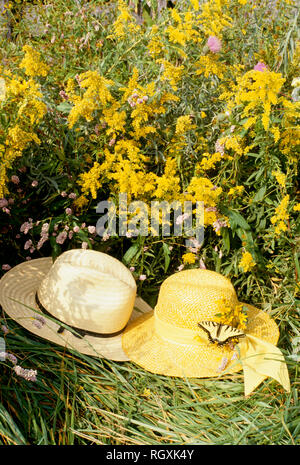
top-left (156, 269), bottom-right (238, 329)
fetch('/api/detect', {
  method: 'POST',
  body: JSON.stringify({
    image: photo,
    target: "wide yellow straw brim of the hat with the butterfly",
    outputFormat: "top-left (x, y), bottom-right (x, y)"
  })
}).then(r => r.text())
top-left (122, 303), bottom-right (279, 378)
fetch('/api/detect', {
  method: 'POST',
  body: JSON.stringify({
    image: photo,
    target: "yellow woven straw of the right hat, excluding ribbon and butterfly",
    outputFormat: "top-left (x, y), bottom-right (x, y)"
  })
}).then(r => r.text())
top-left (122, 269), bottom-right (279, 378)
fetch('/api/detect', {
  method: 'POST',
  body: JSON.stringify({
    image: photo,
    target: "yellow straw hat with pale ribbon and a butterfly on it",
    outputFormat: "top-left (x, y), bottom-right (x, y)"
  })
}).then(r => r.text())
top-left (122, 269), bottom-right (290, 395)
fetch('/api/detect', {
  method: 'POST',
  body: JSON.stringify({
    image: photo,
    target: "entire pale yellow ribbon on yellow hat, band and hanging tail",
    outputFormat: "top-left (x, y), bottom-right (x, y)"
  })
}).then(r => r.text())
top-left (154, 311), bottom-right (290, 396)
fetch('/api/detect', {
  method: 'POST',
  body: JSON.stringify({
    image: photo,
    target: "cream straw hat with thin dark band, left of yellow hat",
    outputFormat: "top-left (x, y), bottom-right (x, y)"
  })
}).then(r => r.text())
top-left (0, 249), bottom-right (152, 361)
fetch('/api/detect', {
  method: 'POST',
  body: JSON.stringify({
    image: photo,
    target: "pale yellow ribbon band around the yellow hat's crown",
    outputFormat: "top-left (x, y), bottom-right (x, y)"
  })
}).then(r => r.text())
top-left (154, 309), bottom-right (208, 345)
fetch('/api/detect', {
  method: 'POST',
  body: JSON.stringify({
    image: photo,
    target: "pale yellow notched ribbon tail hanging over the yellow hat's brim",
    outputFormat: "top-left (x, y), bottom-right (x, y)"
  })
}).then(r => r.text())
top-left (238, 334), bottom-right (290, 396)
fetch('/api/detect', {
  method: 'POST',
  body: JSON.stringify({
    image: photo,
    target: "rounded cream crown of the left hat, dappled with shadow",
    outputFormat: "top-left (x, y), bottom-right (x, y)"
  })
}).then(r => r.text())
top-left (38, 249), bottom-right (136, 334)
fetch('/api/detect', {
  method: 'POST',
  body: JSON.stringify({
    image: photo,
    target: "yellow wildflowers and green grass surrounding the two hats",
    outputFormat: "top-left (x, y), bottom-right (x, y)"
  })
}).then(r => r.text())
top-left (0, 0), bottom-right (300, 444)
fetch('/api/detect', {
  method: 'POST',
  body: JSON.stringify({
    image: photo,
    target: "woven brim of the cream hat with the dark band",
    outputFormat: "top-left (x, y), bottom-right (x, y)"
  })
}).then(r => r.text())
top-left (0, 257), bottom-right (152, 361)
